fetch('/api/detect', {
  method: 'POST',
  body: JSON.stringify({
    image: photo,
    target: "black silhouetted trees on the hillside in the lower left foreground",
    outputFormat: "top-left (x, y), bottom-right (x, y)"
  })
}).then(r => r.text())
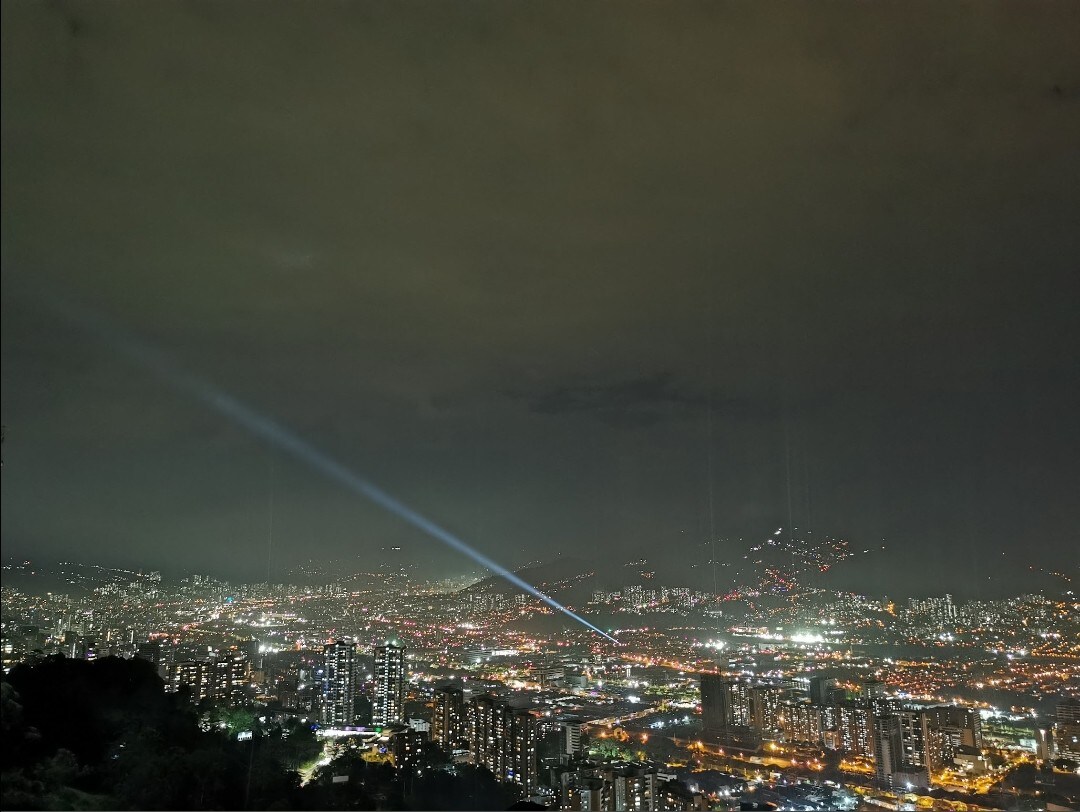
top-left (0, 657), bottom-right (515, 810)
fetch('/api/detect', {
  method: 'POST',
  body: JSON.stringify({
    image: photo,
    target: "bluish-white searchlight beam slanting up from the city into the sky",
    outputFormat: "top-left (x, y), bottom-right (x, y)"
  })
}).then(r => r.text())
top-left (52, 300), bottom-right (619, 644)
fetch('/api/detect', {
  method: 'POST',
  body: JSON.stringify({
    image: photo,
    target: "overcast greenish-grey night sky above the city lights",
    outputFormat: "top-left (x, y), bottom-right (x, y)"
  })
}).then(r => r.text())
top-left (0, 1), bottom-right (1080, 596)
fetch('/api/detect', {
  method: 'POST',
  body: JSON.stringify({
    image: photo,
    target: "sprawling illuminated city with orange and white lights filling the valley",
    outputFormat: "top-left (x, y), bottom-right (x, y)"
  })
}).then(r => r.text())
top-left (2, 560), bottom-right (1080, 810)
